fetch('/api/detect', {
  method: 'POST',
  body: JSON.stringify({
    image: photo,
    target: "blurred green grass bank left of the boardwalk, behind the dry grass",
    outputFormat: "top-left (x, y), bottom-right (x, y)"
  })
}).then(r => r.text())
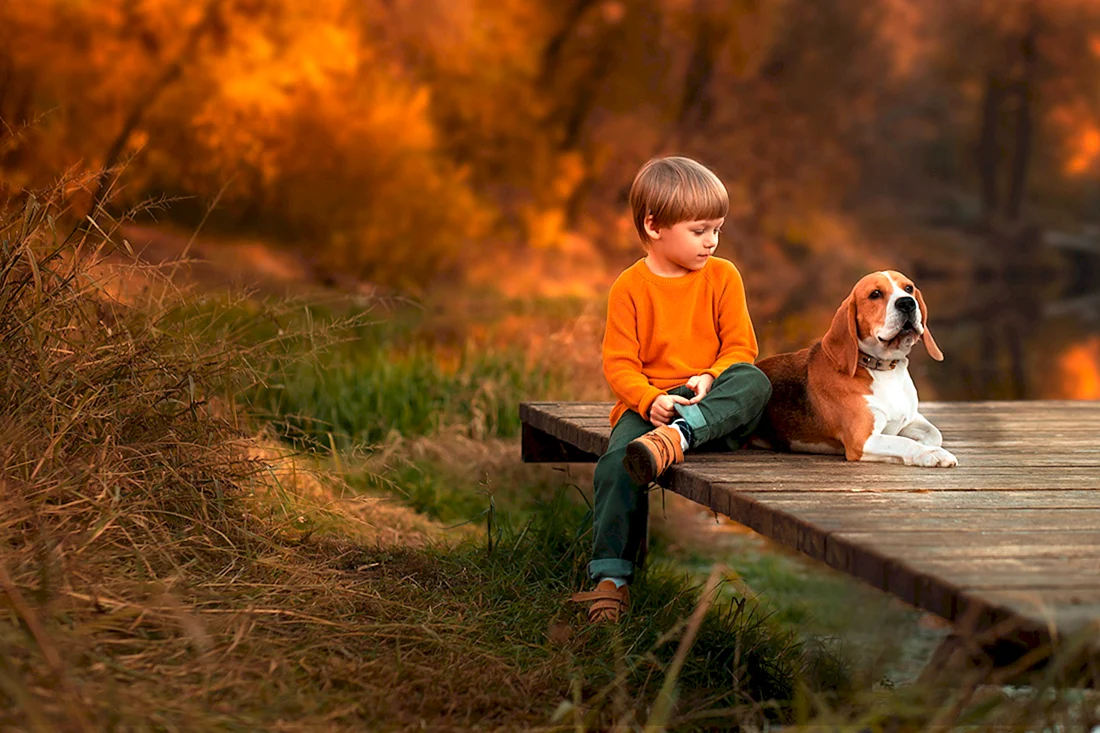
top-left (169, 299), bottom-right (578, 450)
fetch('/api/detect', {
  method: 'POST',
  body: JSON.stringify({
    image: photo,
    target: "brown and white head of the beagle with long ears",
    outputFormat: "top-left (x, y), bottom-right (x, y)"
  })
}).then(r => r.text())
top-left (822, 270), bottom-right (944, 375)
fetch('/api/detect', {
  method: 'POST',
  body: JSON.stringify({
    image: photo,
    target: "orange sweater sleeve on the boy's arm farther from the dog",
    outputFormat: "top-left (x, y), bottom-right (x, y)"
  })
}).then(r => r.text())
top-left (603, 282), bottom-right (663, 419)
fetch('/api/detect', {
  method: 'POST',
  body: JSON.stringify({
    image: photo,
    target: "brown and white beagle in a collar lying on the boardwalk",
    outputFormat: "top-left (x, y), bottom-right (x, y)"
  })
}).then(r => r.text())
top-left (752, 271), bottom-right (958, 467)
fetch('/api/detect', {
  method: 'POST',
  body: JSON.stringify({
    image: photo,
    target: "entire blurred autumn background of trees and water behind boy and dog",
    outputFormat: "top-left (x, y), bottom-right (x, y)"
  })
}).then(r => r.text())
top-left (0, 0), bottom-right (1100, 400)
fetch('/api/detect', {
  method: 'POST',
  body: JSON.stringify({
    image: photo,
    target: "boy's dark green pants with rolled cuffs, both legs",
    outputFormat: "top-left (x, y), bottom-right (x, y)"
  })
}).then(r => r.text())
top-left (589, 362), bottom-right (771, 581)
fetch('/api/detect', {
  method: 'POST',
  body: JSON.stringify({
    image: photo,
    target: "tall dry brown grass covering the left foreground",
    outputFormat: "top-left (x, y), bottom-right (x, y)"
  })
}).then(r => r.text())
top-left (0, 178), bottom-right (521, 731)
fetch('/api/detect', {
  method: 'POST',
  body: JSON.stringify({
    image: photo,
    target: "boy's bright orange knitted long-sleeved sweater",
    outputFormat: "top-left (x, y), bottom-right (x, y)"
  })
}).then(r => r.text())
top-left (603, 258), bottom-right (759, 425)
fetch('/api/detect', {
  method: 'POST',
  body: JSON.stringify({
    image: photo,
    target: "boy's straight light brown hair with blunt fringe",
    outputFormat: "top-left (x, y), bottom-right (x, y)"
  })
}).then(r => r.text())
top-left (630, 155), bottom-right (729, 247)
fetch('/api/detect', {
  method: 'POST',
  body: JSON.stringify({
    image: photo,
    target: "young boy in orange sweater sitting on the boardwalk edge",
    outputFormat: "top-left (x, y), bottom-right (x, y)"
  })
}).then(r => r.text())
top-left (573, 157), bottom-right (771, 623)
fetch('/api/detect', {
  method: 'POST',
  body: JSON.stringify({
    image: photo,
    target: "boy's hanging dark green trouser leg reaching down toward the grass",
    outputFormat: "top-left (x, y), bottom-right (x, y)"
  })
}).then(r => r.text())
top-left (589, 409), bottom-right (653, 582)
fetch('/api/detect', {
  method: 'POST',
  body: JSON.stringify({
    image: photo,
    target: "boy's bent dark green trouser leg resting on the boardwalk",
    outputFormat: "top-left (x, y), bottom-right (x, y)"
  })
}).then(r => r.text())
top-left (670, 362), bottom-right (771, 450)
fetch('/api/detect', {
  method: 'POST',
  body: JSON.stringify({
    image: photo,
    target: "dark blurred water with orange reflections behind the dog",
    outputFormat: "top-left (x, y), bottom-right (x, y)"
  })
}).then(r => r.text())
top-left (758, 238), bottom-right (1100, 401)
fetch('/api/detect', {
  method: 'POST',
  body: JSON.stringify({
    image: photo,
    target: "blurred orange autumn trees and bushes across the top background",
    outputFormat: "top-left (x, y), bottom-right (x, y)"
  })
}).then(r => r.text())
top-left (0, 0), bottom-right (1100, 295)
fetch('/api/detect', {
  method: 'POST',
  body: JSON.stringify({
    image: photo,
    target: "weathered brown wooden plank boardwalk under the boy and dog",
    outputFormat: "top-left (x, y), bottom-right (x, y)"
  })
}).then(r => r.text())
top-left (520, 402), bottom-right (1100, 646)
